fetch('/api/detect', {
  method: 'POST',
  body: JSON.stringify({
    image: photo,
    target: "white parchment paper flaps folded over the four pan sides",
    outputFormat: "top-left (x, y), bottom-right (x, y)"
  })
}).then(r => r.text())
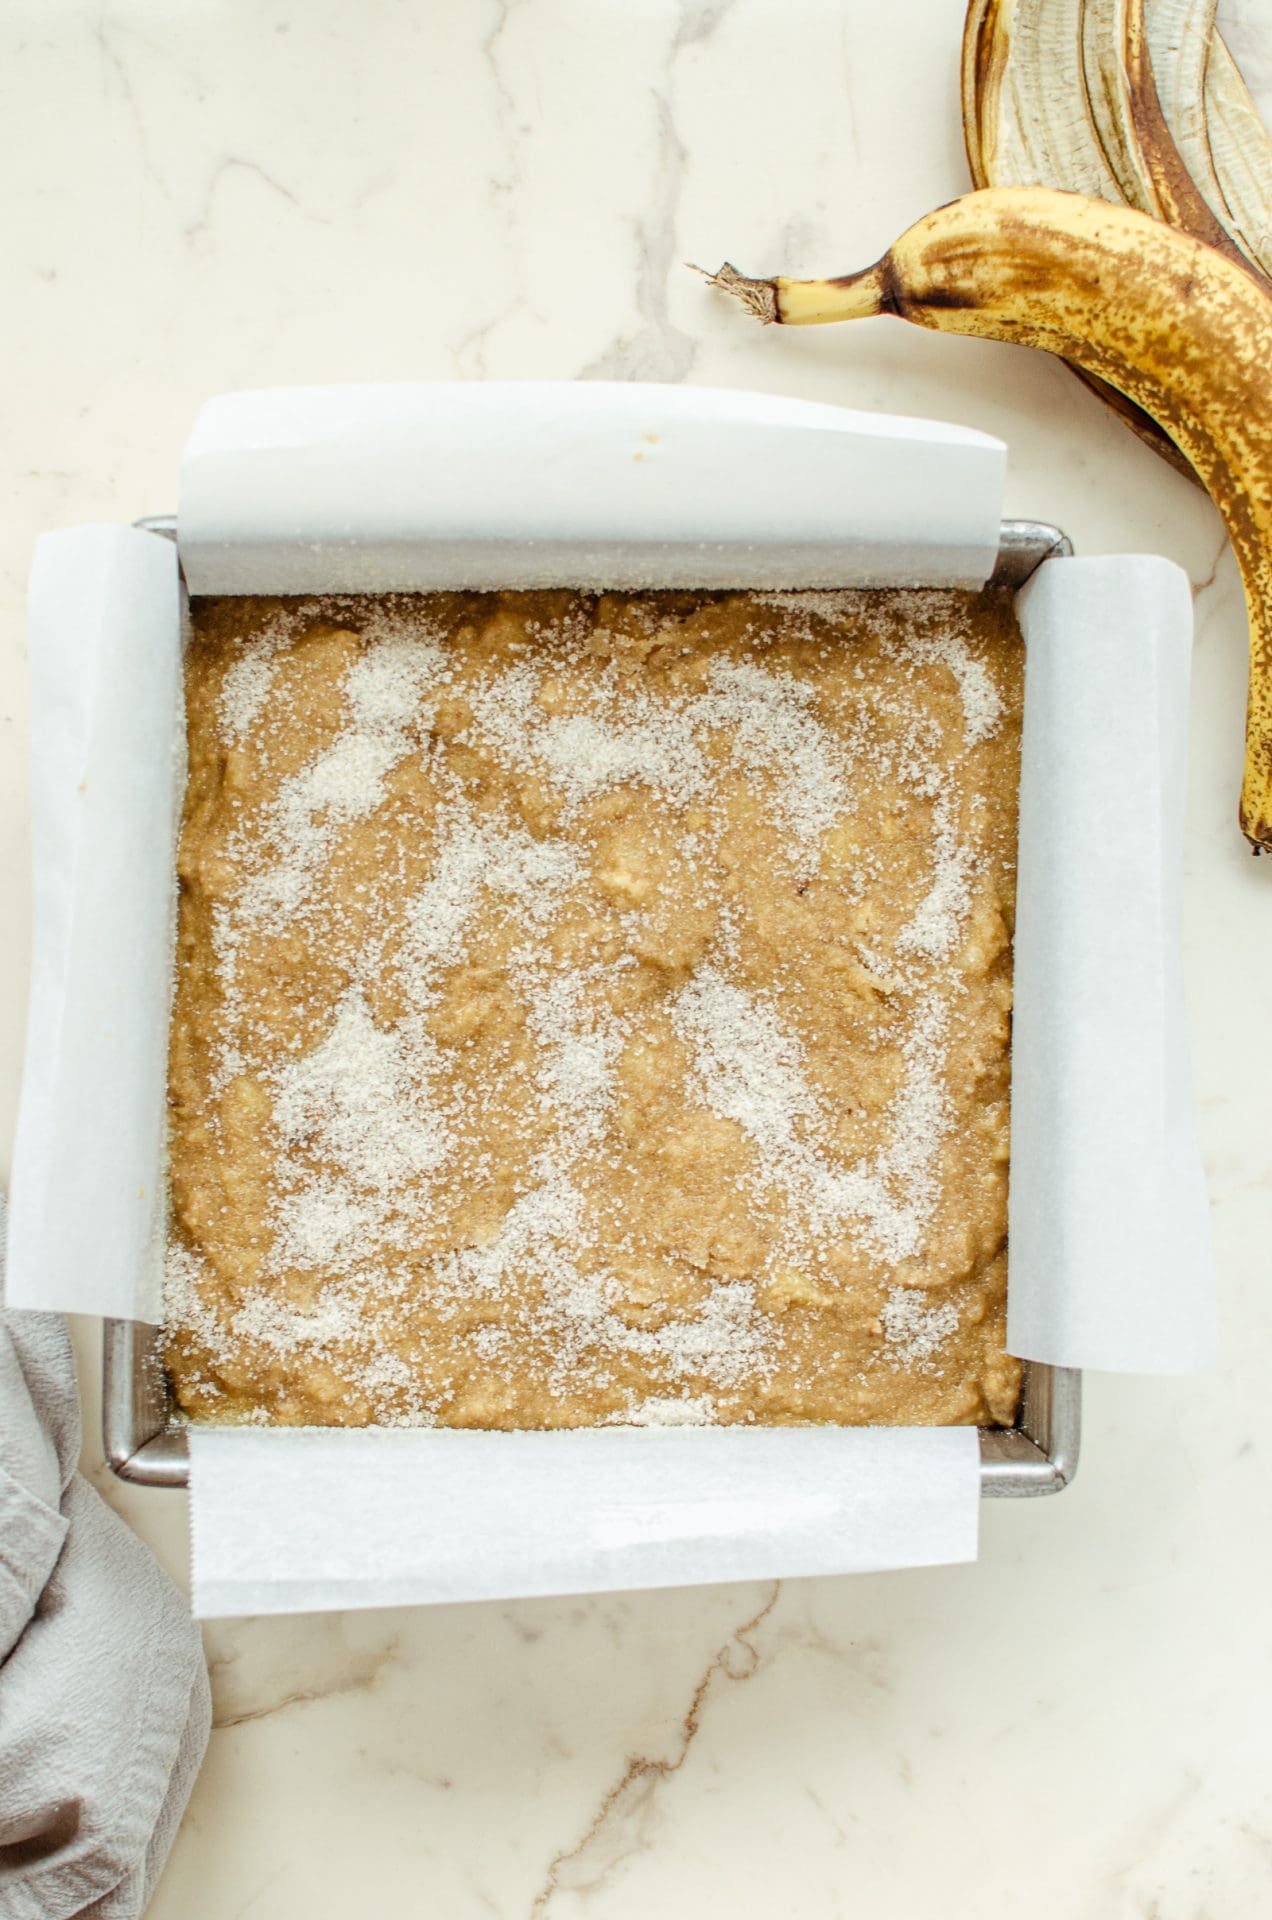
top-left (8, 384), bottom-right (1211, 1613)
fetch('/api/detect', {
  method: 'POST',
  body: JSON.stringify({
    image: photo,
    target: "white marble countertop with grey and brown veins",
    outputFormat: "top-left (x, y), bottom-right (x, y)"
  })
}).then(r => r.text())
top-left (0, 0), bottom-right (1272, 1920)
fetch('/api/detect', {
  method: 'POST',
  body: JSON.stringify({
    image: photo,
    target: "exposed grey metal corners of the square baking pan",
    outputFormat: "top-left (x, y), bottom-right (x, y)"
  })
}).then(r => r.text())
top-left (102, 516), bottom-right (1082, 1500)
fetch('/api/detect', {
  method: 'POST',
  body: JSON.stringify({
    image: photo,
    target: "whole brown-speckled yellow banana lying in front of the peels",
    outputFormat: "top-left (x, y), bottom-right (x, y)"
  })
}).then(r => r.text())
top-left (709, 186), bottom-right (1272, 852)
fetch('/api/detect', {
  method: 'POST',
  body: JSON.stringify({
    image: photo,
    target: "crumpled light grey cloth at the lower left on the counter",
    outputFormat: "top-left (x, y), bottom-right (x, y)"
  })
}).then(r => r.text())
top-left (0, 1200), bottom-right (211, 1920)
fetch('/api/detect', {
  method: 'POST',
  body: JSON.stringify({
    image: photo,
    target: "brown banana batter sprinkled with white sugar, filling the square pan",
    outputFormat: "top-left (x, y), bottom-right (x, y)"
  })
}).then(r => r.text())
top-left (167, 591), bottom-right (1022, 1428)
